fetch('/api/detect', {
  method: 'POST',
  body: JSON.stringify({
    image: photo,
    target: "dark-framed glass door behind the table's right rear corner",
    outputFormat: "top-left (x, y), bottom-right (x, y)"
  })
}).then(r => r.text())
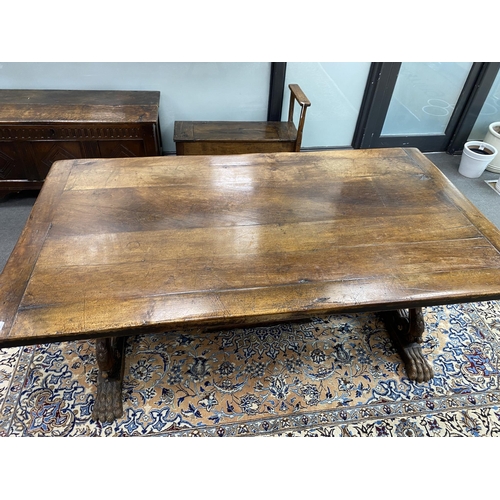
top-left (353, 62), bottom-right (485, 151)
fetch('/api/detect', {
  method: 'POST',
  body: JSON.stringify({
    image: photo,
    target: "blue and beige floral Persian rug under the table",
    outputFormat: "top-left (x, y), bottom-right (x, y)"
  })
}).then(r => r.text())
top-left (0, 301), bottom-right (500, 437)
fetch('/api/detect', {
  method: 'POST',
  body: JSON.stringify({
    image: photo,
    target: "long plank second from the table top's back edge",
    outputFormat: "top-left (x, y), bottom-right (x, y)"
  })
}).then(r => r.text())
top-left (49, 175), bottom-right (452, 235)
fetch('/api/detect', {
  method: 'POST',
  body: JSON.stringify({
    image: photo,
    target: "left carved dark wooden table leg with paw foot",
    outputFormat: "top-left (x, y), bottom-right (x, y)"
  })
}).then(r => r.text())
top-left (92, 337), bottom-right (125, 422)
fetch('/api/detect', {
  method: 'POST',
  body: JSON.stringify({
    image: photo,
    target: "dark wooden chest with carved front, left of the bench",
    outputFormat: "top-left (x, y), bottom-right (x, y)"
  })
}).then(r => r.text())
top-left (0, 90), bottom-right (161, 197)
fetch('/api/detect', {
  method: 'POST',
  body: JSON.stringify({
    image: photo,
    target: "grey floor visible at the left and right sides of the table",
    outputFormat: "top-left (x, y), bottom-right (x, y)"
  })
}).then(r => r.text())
top-left (0, 153), bottom-right (500, 276)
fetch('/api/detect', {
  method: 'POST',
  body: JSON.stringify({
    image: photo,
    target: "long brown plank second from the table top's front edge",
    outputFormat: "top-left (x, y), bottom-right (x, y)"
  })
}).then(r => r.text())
top-left (20, 238), bottom-right (500, 309)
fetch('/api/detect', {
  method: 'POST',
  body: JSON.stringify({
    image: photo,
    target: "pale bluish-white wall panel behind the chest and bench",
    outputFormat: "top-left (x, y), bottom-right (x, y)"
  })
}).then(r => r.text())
top-left (0, 62), bottom-right (271, 153)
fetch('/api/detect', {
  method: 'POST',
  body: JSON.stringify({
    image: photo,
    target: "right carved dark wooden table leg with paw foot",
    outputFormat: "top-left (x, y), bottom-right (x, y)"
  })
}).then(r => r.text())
top-left (380, 307), bottom-right (434, 382)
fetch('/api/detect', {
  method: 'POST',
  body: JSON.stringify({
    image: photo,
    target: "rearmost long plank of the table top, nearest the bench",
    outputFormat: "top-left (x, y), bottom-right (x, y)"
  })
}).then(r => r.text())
top-left (61, 150), bottom-right (422, 190)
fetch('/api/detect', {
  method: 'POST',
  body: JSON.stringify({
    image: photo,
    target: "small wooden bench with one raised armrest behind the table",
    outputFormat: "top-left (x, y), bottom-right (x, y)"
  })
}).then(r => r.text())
top-left (174, 83), bottom-right (311, 155)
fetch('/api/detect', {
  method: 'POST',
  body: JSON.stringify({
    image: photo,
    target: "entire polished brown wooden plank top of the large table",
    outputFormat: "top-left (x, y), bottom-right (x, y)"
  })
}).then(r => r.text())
top-left (0, 149), bottom-right (500, 346)
